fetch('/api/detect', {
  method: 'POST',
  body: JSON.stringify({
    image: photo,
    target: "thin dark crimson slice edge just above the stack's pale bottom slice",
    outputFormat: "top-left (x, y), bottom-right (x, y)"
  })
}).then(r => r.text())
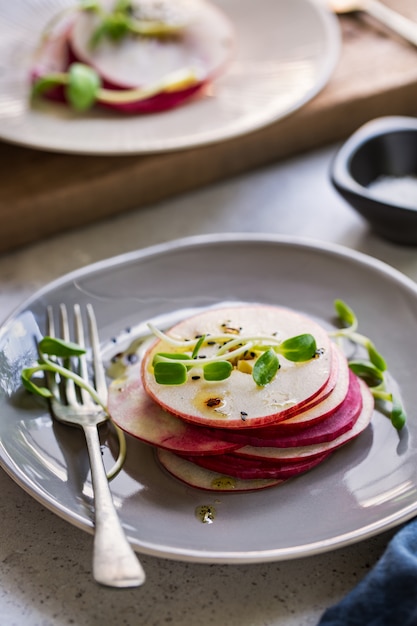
top-left (180, 453), bottom-right (329, 480)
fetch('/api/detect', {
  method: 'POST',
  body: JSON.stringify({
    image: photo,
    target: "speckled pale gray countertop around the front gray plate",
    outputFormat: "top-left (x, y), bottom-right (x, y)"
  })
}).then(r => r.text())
top-left (0, 147), bottom-right (417, 626)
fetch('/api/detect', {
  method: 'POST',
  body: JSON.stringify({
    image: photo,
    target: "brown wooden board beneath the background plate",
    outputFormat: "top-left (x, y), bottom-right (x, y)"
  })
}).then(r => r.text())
top-left (0, 0), bottom-right (417, 253)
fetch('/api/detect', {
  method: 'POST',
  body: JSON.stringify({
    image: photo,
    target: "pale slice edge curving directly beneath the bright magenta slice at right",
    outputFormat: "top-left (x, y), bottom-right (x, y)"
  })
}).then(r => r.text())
top-left (230, 379), bottom-right (374, 463)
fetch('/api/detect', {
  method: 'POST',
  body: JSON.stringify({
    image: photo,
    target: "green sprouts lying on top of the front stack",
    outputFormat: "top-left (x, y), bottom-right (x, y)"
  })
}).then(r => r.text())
top-left (149, 324), bottom-right (317, 387)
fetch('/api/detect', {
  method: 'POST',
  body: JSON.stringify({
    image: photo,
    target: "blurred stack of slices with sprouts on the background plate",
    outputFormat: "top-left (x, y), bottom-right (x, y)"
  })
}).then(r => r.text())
top-left (31, 0), bottom-right (234, 113)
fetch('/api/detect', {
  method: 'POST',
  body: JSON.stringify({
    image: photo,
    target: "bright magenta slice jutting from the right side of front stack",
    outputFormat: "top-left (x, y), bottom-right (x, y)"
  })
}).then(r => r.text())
top-left (221, 372), bottom-right (362, 448)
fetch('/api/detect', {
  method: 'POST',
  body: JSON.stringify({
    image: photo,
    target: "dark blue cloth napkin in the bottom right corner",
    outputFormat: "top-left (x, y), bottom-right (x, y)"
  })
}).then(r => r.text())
top-left (317, 520), bottom-right (417, 626)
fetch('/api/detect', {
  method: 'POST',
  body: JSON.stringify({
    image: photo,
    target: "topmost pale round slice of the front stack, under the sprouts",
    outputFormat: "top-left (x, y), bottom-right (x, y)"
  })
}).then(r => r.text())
top-left (142, 305), bottom-right (332, 429)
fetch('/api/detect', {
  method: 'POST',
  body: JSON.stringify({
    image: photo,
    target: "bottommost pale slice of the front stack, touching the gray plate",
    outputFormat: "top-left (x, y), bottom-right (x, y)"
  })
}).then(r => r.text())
top-left (157, 450), bottom-right (284, 493)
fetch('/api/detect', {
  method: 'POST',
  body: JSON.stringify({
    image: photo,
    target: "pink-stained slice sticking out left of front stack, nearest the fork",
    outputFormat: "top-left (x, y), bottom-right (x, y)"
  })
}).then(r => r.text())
top-left (108, 365), bottom-right (239, 454)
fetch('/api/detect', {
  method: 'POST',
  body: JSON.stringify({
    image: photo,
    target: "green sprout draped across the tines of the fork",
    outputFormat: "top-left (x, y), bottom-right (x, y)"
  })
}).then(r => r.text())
top-left (21, 336), bottom-right (126, 480)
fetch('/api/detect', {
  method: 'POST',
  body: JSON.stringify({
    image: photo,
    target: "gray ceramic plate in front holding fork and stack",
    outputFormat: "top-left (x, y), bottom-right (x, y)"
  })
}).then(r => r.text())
top-left (0, 235), bottom-right (417, 563)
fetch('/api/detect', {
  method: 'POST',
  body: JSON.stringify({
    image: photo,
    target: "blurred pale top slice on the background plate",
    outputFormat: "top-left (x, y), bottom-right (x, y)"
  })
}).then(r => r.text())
top-left (70, 0), bottom-right (234, 89)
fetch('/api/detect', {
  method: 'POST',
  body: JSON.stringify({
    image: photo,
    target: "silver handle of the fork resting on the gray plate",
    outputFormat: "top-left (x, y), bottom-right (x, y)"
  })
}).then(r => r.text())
top-left (83, 424), bottom-right (145, 587)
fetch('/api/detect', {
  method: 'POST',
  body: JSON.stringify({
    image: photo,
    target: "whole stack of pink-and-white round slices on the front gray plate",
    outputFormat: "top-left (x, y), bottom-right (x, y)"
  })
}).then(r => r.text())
top-left (108, 305), bottom-right (374, 491)
